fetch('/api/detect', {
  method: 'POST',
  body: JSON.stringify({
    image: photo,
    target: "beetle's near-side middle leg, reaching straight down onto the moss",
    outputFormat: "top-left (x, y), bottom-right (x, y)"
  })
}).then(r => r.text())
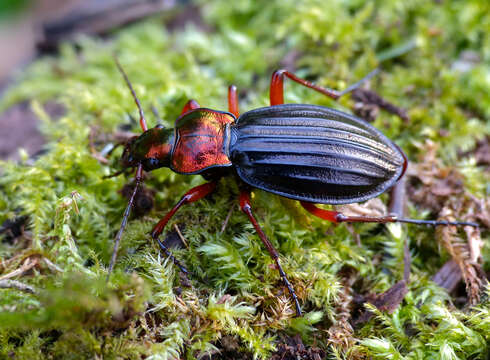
top-left (240, 190), bottom-right (301, 316)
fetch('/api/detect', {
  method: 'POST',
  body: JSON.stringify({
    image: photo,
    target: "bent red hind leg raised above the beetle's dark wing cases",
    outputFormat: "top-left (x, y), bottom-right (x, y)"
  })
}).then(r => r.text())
top-left (270, 69), bottom-right (379, 106)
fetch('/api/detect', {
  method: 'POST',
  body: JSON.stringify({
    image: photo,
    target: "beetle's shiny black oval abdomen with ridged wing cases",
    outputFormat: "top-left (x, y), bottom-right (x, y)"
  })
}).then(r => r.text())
top-left (230, 104), bottom-right (405, 204)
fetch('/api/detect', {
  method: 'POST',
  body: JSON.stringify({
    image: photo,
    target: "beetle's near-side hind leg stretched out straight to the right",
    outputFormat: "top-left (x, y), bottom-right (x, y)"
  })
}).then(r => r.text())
top-left (300, 201), bottom-right (478, 227)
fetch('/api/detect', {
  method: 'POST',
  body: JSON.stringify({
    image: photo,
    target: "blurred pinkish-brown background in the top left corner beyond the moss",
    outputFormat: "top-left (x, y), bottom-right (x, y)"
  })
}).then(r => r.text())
top-left (0, 0), bottom-right (178, 84)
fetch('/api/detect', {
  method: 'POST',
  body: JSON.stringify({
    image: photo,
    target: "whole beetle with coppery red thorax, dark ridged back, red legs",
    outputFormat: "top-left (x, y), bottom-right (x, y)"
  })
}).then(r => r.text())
top-left (108, 59), bottom-right (478, 316)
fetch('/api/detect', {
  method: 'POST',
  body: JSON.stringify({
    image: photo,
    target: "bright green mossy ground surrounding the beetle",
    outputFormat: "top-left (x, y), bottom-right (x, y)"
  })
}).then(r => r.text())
top-left (0, 0), bottom-right (490, 359)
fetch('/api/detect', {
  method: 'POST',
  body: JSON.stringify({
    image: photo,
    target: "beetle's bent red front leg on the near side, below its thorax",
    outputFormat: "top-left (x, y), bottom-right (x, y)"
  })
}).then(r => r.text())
top-left (151, 181), bottom-right (217, 274)
